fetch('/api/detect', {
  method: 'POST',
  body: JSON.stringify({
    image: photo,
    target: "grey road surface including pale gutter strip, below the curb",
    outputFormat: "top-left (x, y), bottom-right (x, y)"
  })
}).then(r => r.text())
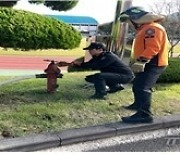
top-left (41, 128), bottom-right (180, 152)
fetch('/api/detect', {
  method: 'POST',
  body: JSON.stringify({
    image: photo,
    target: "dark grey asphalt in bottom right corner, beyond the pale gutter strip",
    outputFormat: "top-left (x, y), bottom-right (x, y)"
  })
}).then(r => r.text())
top-left (89, 136), bottom-right (180, 152)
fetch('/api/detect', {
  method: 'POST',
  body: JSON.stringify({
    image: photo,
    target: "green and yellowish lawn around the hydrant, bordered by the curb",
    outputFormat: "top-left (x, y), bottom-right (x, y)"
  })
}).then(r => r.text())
top-left (0, 72), bottom-right (180, 136)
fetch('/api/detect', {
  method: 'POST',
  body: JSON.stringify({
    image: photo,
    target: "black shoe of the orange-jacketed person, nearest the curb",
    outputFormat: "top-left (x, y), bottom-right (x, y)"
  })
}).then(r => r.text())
top-left (121, 111), bottom-right (153, 124)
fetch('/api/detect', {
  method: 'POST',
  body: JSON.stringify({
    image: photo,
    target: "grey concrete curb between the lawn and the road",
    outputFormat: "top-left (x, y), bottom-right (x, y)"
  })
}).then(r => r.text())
top-left (0, 115), bottom-right (180, 152)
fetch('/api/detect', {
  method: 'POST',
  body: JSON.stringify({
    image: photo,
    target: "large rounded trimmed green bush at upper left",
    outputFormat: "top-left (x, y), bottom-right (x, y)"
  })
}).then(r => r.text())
top-left (0, 8), bottom-right (81, 50)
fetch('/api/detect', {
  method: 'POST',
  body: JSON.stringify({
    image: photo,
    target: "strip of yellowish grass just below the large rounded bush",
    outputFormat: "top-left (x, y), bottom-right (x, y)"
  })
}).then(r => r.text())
top-left (0, 39), bottom-right (86, 56)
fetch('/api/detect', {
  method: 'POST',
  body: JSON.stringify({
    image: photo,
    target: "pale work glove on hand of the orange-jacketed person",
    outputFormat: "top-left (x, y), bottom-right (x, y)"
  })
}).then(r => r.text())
top-left (131, 58), bottom-right (149, 73)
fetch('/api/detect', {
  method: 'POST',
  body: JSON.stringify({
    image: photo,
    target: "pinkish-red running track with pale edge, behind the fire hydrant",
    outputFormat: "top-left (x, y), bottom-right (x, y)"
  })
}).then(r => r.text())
top-left (0, 55), bottom-right (78, 75)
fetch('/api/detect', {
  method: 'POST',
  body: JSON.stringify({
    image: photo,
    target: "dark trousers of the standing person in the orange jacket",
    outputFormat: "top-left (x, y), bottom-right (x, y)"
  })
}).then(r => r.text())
top-left (132, 65), bottom-right (166, 112)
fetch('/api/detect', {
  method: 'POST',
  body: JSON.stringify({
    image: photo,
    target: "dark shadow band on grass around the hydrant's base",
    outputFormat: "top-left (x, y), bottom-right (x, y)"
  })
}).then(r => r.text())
top-left (0, 83), bottom-right (94, 105)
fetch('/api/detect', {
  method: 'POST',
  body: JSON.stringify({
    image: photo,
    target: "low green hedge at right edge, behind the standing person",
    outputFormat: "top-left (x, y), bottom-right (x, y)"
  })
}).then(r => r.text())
top-left (158, 58), bottom-right (180, 83)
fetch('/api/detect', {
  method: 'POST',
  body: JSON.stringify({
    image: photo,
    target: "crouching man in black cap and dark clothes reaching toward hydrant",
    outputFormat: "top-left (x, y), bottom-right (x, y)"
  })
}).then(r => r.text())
top-left (73, 42), bottom-right (134, 99)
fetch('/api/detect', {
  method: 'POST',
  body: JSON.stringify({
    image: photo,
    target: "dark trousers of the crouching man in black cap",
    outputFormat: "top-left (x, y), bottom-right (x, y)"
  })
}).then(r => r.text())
top-left (85, 73), bottom-right (134, 95)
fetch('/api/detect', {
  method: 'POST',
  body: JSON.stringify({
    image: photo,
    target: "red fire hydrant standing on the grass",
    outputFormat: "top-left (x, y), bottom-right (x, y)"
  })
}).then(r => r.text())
top-left (44, 61), bottom-right (63, 93)
